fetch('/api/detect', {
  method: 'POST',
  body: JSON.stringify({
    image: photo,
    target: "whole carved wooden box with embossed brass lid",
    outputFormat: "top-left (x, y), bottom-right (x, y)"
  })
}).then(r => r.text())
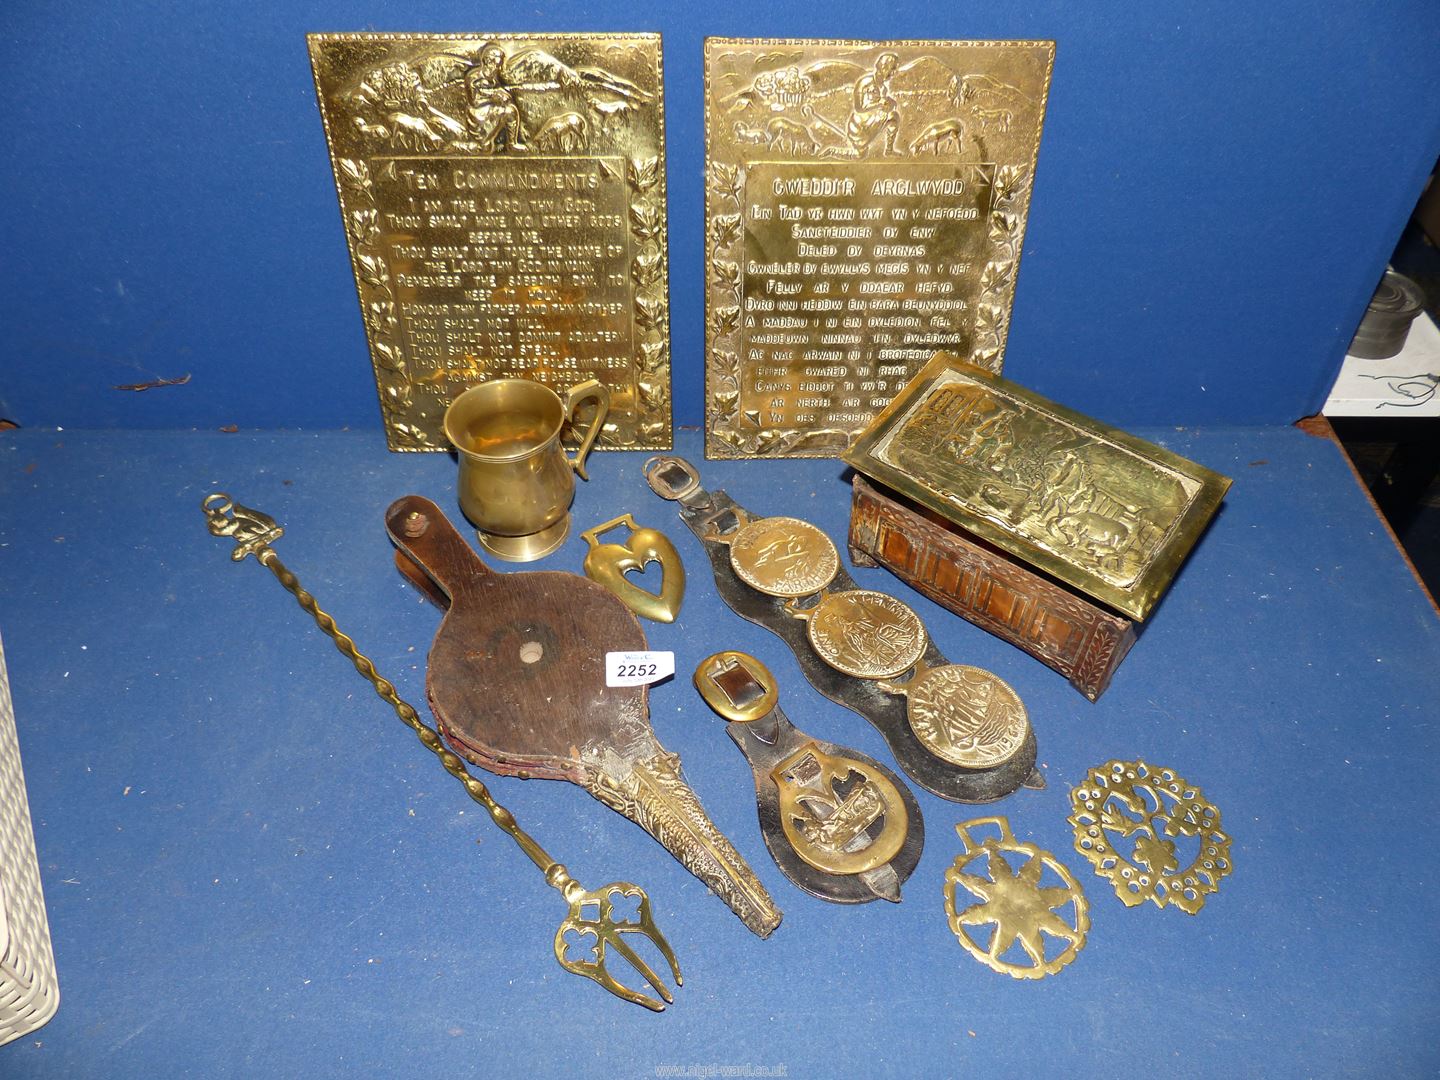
top-left (844, 353), bottom-right (1230, 700)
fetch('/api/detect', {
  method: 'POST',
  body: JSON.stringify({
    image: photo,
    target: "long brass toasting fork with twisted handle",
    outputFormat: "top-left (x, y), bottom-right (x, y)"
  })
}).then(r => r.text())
top-left (200, 491), bottom-right (684, 1012)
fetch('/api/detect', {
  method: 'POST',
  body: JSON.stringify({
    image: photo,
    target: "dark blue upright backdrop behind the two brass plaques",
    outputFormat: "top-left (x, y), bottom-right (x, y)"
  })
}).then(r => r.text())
top-left (0, 0), bottom-right (1440, 429)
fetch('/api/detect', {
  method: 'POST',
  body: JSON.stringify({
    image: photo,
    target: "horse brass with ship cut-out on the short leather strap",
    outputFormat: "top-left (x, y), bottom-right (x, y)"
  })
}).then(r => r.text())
top-left (770, 742), bottom-right (906, 874)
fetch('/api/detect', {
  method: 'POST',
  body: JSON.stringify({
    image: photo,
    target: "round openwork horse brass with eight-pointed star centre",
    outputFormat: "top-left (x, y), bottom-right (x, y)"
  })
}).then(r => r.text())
top-left (945, 818), bottom-right (1090, 979)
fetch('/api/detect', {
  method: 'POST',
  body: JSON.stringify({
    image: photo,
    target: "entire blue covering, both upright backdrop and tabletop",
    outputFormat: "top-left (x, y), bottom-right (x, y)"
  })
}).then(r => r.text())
top-left (0, 0), bottom-right (1440, 1079)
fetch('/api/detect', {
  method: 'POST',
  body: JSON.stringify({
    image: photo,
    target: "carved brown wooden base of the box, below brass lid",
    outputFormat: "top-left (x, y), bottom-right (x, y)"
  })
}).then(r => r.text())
top-left (850, 474), bottom-right (1138, 701)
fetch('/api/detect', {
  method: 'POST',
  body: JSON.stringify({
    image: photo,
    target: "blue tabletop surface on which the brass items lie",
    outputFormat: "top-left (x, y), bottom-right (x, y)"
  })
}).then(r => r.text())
top-left (0, 429), bottom-right (1440, 1080)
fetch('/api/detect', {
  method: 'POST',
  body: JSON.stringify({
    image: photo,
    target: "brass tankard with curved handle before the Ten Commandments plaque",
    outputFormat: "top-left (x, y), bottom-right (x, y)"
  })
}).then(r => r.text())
top-left (445, 379), bottom-right (611, 563)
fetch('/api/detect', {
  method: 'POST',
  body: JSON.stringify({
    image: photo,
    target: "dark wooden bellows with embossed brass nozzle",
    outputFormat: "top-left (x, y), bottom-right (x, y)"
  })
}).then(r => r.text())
top-left (384, 495), bottom-right (780, 937)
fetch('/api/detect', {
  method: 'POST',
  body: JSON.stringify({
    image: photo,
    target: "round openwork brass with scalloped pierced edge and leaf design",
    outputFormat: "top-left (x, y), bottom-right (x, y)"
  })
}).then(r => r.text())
top-left (1068, 762), bottom-right (1231, 914)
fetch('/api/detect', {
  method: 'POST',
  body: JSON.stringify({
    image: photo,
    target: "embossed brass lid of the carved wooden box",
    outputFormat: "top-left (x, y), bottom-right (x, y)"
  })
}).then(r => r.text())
top-left (844, 353), bottom-right (1230, 619)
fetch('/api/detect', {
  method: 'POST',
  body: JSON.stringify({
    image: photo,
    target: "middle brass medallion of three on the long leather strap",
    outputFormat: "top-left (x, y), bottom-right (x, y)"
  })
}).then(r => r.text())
top-left (786, 589), bottom-right (927, 678)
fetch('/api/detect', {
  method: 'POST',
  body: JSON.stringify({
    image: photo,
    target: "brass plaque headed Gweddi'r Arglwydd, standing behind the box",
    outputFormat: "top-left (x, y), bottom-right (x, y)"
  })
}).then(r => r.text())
top-left (706, 37), bottom-right (1054, 458)
